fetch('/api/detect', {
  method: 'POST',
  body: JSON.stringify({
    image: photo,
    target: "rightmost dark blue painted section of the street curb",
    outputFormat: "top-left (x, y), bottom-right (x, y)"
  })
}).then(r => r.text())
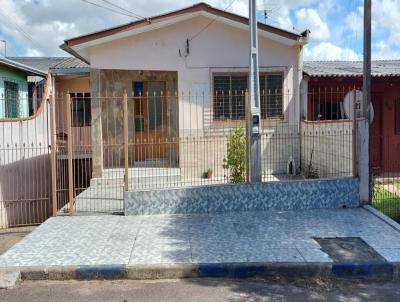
top-left (332, 261), bottom-right (395, 279)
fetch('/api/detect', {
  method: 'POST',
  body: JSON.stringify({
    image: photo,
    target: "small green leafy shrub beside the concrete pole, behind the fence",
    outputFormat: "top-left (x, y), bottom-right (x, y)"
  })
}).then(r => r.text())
top-left (223, 127), bottom-right (246, 183)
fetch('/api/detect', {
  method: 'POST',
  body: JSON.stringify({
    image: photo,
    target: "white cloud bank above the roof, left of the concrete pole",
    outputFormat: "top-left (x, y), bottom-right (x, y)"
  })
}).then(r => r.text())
top-left (0, 0), bottom-right (253, 55)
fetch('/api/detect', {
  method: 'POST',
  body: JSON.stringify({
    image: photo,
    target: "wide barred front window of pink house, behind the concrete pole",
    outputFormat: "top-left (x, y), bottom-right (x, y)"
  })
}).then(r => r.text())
top-left (213, 74), bottom-right (283, 120)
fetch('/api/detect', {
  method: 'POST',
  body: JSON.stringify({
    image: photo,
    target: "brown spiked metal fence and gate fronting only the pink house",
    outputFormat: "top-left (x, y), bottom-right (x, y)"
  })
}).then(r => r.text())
top-left (55, 91), bottom-right (355, 213)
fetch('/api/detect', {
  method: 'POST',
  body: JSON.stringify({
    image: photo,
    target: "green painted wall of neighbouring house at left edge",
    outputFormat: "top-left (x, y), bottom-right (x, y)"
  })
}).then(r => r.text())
top-left (0, 65), bottom-right (29, 118)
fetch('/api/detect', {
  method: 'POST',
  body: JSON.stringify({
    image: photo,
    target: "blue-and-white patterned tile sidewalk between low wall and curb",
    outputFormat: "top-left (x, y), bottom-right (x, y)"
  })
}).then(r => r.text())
top-left (0, 208), bottom-right (400, 266)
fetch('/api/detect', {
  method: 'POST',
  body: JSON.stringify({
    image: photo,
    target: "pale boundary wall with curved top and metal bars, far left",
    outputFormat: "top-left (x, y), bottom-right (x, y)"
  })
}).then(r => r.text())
top-left (0, 102), bottom-right (51, 228)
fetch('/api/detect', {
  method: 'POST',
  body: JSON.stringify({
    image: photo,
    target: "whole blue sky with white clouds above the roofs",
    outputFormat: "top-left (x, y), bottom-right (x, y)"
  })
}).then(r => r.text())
top-left (0, 0), bottom-right (400, 60)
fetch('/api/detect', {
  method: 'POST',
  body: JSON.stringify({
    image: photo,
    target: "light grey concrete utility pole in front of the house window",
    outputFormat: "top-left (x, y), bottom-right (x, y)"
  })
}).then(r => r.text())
top-left (247, 0), bottom-right (261, 183)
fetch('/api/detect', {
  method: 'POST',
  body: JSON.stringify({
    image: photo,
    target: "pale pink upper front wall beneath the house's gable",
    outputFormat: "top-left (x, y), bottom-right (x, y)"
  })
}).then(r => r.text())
top-left (90, 16), bottom-right (302, 129)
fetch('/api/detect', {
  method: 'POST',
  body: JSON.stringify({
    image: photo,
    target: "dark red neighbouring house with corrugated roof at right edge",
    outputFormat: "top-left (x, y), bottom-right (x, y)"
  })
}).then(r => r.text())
top-left (303, 60), bottom-right (400, 172)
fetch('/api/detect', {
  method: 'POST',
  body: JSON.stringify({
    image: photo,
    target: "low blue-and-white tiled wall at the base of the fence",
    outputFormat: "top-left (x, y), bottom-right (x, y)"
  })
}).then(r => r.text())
top-left (124, 178), bottom-right (360, 215)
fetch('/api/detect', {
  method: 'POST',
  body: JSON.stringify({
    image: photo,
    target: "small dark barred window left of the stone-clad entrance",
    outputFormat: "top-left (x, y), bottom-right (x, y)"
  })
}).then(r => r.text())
top-left (70, 92), bottom-right (92, 127)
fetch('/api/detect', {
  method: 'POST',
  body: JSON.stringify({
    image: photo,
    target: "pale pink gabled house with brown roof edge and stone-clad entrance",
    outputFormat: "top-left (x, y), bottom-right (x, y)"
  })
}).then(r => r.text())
top-left (62, 3), bottom-right (308, 177)
